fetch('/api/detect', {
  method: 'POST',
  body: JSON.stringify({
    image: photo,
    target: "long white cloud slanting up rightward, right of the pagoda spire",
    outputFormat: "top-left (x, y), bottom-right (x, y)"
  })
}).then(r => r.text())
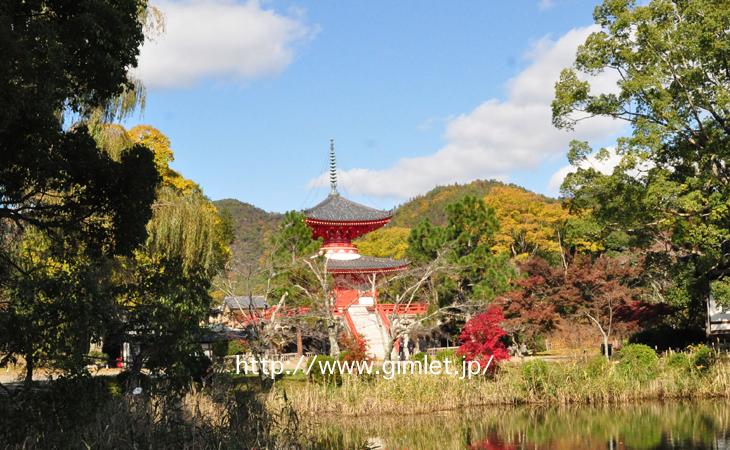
top-left (310, 26), bottom-right (624, 199)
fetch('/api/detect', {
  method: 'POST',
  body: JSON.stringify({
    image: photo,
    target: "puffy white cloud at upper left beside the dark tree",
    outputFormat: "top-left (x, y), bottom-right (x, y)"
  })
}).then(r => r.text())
top-left (133, 0), bottom-right (317, 87)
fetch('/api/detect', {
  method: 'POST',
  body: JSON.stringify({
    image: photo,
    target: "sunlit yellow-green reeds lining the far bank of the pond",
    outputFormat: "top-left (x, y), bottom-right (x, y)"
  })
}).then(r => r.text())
top-left (265, 350), bottom-right (730, 416)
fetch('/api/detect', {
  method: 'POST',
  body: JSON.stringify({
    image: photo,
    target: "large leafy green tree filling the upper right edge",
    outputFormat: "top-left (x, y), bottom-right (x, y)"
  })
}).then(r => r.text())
top-left (552, 0), bottom-right (730, 320)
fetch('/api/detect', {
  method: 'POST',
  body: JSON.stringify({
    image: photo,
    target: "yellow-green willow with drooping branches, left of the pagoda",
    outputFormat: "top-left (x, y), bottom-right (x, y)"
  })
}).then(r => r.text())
top-left (90, 124), bottom-right (232, 384)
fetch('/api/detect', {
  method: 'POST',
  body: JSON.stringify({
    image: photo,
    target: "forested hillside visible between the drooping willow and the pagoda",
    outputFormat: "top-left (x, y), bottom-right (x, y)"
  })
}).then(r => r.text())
top-left (213, 198), bottom-right (282, 265)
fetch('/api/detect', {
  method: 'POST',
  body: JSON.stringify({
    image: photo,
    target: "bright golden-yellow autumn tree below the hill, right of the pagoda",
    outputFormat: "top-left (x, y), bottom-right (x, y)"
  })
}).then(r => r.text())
top-left (484, 186), bottom-right (570, 256)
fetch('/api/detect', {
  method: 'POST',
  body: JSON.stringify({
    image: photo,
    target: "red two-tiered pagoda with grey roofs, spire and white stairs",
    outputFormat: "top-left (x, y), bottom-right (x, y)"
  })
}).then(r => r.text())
top-left (304, 141), bottom-right (427, 359)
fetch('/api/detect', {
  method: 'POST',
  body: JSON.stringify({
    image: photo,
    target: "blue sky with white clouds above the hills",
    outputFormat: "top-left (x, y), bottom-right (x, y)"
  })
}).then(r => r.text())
top-left (123, 0), bottom-right (621, 211)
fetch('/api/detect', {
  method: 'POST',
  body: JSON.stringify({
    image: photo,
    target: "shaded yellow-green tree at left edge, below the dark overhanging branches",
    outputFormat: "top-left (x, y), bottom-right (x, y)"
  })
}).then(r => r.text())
top-left (0, 232), bottom-right (113, 384)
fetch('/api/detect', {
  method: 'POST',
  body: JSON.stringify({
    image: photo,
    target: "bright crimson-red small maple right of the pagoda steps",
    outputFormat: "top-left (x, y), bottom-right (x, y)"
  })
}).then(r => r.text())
top-left (456, 306), bottom-right (509, 366)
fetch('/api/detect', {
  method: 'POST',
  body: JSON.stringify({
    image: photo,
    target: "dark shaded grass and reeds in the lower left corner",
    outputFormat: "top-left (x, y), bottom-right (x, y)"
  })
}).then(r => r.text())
top-left (0, 377), bottom-right (301, 449)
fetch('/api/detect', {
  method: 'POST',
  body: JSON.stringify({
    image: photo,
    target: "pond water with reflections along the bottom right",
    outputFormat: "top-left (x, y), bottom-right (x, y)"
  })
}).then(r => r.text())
top-left (304, 399), bottom-right (730, 450)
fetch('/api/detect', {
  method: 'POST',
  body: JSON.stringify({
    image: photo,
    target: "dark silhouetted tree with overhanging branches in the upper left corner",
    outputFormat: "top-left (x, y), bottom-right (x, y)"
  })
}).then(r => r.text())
top-left (0, 0), bottom-right (155, 252)
